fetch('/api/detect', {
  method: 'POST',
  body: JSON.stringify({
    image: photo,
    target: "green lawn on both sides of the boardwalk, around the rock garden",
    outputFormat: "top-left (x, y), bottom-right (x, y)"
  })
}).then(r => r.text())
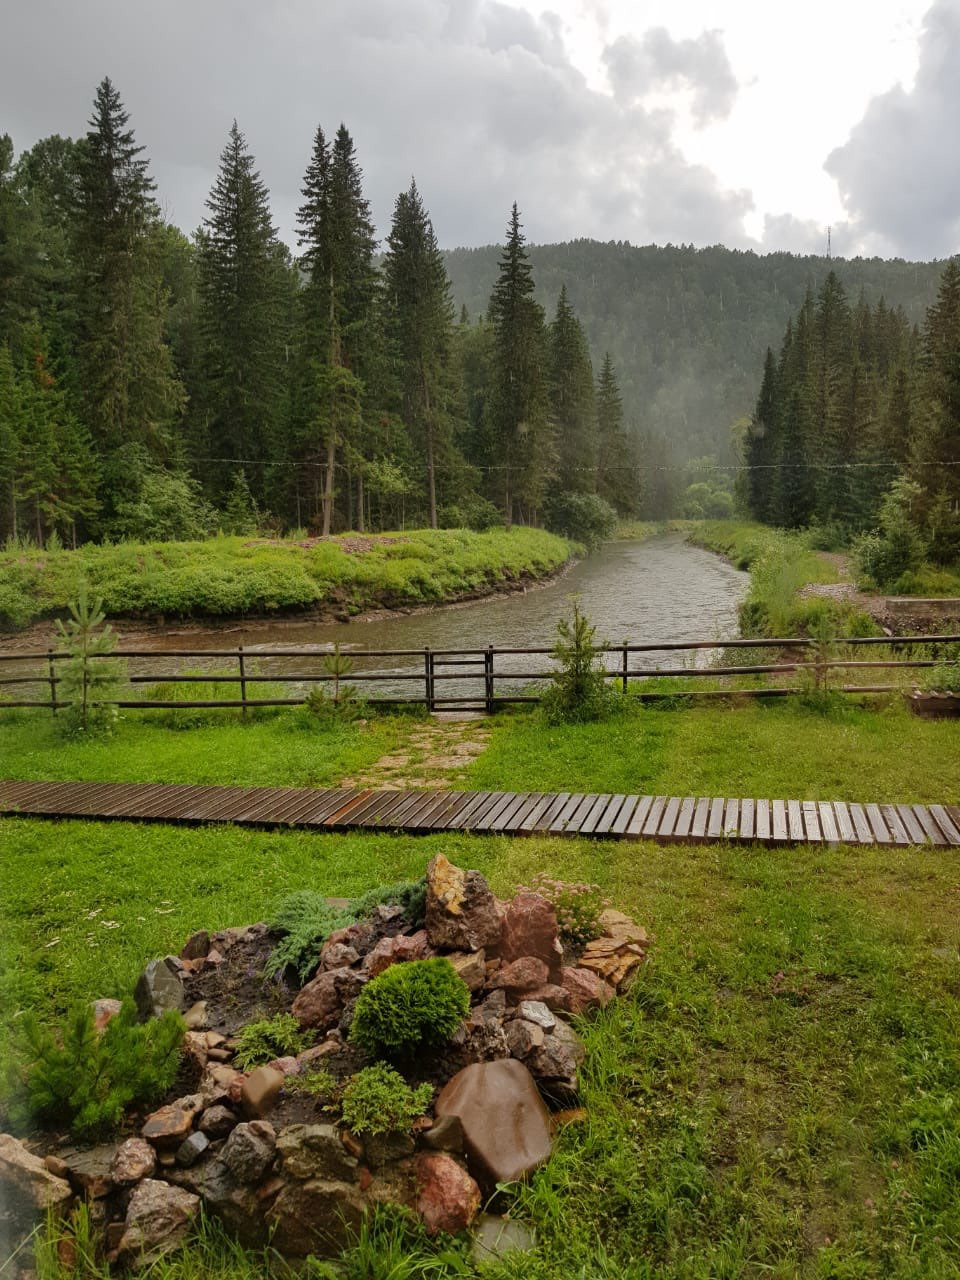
top-left (0, 704), bottom-right (960, 1280)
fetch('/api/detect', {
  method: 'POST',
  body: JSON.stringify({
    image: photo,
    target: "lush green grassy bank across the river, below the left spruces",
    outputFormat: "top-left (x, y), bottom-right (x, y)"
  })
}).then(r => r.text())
top-left (0, 527), bottom-right (573, 628)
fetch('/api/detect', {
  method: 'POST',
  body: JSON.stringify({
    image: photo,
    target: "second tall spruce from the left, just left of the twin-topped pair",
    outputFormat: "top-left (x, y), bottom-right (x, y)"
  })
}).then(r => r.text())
top-left (195, 120), bottom-right (293, 500)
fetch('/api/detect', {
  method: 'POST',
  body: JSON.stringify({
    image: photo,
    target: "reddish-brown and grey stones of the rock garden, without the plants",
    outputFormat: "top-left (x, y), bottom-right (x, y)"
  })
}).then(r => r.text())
top-left (0, 855), bottom-right (648, 1268)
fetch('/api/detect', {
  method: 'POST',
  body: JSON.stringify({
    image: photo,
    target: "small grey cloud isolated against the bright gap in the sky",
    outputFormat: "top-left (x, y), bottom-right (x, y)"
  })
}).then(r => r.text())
top-left (603, 27), bottom-right (740, 124)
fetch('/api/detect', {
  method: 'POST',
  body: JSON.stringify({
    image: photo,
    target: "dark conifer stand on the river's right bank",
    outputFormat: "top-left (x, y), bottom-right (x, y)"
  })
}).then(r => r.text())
top-left (741, 266), bottom-right (960, 594)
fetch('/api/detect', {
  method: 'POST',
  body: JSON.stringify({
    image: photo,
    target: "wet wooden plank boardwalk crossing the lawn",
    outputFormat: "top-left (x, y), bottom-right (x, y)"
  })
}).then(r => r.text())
top-left (0, 782), bottom-right (960, 847)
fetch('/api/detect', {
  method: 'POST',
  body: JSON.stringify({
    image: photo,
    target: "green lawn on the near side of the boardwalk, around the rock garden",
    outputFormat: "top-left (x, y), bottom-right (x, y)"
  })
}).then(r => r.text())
top-left (0, 819), bottom-right (960, 1280)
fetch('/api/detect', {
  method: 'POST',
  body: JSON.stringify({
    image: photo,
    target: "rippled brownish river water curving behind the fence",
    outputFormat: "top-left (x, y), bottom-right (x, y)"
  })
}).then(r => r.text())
top-left (3, 535), bottom-right (749, 698)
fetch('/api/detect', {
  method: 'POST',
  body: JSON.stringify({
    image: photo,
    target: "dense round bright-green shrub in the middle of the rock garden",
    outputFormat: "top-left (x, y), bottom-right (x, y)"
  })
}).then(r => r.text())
top-left (349, 956), bottom-right (470, 1057)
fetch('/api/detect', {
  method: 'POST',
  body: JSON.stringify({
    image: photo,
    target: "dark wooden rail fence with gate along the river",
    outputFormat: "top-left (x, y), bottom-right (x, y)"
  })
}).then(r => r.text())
top-left (0, 635), bottom-right (960, 714)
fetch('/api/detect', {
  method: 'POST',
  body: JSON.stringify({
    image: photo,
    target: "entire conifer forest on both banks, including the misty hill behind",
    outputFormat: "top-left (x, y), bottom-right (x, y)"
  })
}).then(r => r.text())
top-left (0, 79), bottom-right (960, 557)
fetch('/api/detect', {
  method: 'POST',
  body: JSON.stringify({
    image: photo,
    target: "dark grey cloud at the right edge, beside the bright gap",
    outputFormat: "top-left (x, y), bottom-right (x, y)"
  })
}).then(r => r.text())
top-left (826, 0), bottom-right (960, 257)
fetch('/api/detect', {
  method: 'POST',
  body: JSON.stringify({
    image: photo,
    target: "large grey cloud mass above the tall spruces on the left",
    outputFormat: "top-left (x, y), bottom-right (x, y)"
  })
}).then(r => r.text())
top-left (0, 0), bottom-right (753, 246)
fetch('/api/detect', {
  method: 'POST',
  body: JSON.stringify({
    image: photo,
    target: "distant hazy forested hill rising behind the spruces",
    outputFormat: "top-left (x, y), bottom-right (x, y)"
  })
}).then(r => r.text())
top-left (444, 239), bottom-right (942, 463)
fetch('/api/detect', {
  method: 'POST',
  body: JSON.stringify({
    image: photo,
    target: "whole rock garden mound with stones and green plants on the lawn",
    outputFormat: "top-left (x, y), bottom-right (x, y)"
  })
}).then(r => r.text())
top-left (0, 855), bottom-right (648, 1274)
